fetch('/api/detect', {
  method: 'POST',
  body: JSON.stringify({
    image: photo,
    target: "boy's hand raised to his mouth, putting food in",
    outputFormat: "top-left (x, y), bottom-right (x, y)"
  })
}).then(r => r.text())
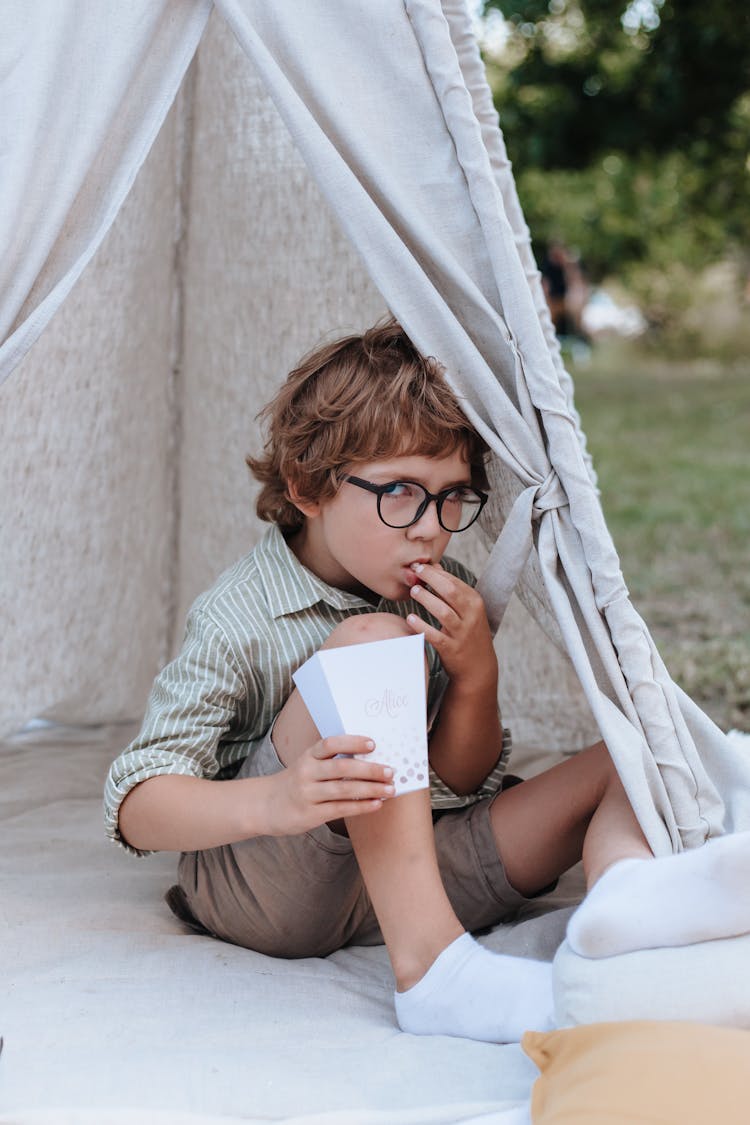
top-left (407, 563), bottom-right (497, 694)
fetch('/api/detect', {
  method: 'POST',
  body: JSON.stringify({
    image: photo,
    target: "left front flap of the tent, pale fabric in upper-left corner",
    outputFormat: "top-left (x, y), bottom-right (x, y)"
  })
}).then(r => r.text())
top-left (0, 0), bottom-right (211, 384)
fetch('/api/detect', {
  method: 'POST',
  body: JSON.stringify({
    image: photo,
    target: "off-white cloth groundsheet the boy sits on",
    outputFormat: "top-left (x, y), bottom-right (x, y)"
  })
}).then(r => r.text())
top-left (0, 727), bottom-right (579, 1125)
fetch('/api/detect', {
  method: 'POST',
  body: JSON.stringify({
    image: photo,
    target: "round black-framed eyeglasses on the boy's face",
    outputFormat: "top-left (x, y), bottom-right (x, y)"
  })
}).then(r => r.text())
top-left (344, 476), bottom-right (488, 532)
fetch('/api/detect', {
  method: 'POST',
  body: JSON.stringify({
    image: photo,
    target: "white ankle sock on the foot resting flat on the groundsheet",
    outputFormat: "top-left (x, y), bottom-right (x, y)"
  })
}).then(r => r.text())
top-left (396, 934), bottom-right (554, 1043)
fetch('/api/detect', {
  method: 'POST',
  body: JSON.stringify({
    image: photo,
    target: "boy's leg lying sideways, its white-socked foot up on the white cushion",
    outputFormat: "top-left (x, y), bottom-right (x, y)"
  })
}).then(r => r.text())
top-left (493, 743), bottom-right (750, 957)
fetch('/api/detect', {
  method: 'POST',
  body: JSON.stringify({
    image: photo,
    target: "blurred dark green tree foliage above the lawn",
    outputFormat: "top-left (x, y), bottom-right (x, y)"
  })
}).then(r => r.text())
top-left (486, 0), bottom-right (750, 331)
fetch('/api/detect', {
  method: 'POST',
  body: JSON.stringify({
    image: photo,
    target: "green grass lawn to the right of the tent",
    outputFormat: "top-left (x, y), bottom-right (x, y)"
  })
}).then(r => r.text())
top-left (571, 345), bottom-right (750, 731)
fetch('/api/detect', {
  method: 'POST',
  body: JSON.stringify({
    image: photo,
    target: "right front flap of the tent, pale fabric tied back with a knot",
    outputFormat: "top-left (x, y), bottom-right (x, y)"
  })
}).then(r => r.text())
top-left (210, 0), bottom-right (723, 853)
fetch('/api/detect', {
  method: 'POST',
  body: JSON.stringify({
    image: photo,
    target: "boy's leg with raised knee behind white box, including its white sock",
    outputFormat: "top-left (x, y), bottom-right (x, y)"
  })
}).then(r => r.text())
top-left (274, 614), bottom-right (552, 1042)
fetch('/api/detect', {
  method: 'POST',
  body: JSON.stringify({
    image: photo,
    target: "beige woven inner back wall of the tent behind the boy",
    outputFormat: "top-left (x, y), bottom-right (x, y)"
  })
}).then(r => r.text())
top-left (0, 14), bottom-right (597, 749)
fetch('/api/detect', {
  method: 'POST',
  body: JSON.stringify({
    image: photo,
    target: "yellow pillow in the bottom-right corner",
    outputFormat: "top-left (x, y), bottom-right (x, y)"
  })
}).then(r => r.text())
top-left (522, 1020), bottom-right (750, 1125)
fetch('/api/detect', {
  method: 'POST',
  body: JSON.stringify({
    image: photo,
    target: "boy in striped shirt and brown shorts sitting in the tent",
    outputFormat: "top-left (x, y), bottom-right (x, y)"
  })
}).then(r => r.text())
top-left (106, 322), bottom-right (750, 1042)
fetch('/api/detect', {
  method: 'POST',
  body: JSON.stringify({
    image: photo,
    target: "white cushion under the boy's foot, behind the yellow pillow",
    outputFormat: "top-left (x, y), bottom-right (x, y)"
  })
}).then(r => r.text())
top-left (553, 934), bottom-right (750, 1030)
